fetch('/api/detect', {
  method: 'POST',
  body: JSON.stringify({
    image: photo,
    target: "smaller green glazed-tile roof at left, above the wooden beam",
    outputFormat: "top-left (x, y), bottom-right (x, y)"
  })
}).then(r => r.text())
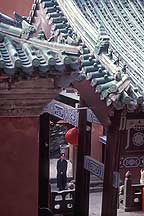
top-left (0, 20), bottom-right (79, 76)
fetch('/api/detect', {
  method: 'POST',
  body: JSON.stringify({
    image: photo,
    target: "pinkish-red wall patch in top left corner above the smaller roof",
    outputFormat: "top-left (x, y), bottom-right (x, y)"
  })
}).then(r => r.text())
top-left (0, 0), bottom-right (33, 17)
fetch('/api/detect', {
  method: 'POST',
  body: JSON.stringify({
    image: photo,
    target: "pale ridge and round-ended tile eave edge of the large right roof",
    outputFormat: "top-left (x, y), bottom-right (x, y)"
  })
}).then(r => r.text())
top-left (29, 0), bottom-right (143, 111)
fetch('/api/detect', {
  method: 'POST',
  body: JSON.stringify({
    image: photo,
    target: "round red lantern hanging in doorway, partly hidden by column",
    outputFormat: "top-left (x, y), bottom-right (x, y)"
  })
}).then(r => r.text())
top-left (65, 128), bottom-right (78, 145)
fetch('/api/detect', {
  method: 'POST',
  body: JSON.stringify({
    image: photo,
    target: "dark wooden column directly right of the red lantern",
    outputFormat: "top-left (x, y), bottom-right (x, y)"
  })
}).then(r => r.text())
top-left (74, 100), bottom-right (91, 216)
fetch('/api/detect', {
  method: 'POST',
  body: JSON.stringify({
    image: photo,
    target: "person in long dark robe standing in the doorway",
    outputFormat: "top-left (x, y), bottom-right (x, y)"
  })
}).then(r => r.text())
top-left (57, 153), bottom-right (67, 191)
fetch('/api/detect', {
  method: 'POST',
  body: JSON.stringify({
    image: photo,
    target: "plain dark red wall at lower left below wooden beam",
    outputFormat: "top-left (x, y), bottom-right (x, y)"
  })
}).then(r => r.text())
top-left (0, 117), bottom-right (39, 216)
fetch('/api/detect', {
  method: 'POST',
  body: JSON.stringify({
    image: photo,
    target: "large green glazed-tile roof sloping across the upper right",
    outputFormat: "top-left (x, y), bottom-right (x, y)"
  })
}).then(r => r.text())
top-left (28, 0), bottom-right (144, 111)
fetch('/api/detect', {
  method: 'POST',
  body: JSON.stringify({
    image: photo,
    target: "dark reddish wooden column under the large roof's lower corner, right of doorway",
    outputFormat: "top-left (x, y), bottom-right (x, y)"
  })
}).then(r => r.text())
top-left (101, 114), bottom-right (123, 216)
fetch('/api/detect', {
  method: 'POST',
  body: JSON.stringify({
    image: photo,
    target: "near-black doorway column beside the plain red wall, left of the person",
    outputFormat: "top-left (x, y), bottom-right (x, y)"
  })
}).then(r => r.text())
top-left (39, 113), bottom-right (50, 208)
